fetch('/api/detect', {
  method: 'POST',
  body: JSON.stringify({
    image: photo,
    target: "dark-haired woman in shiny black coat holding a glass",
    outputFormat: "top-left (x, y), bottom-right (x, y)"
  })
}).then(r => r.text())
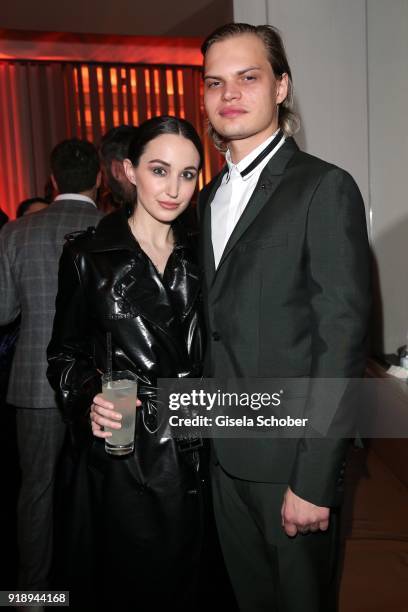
top-left (48, 117), bottom-right (203, 610)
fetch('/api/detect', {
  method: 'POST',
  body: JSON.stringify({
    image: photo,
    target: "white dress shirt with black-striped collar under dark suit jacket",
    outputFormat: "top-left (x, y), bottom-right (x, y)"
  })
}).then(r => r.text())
top-left (211, 130), bottom-right (285, 268)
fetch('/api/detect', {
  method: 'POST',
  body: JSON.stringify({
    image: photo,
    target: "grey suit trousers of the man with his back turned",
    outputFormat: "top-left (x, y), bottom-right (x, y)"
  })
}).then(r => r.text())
top-left (16, 407), bottom-right (66, 590)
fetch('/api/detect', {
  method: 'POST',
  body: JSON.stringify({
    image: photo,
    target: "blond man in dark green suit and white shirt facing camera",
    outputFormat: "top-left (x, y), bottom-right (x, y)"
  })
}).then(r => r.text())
top-left (199, 24), bottom-right (370, 612)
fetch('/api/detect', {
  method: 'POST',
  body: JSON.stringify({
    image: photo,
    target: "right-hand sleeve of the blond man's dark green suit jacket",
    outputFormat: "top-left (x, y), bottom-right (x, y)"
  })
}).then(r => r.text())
top-left (290, 168), bottom-right (371, 506)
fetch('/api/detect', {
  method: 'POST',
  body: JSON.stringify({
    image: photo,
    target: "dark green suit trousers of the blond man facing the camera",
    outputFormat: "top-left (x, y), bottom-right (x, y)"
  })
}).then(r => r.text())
top-left (212, 463), bottom-right (339, 612)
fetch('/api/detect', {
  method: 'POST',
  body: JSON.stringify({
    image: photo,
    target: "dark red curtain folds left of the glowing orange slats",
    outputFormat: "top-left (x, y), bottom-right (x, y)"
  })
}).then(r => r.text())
top-left (0, 62), bottom-right (70, 218)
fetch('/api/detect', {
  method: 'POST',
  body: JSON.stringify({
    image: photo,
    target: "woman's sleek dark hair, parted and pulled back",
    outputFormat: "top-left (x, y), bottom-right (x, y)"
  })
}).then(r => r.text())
top-left (129, 115), bottom-right (204, 170)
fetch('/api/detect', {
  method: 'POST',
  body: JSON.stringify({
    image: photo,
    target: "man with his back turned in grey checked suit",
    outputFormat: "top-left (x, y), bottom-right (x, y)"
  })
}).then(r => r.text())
top-left (0, 139), bottom-right (102, 590)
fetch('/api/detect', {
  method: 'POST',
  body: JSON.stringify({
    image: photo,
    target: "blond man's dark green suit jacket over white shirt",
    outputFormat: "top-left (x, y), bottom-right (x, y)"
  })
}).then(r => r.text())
top-left (199, 138), bottom-right (370, 506)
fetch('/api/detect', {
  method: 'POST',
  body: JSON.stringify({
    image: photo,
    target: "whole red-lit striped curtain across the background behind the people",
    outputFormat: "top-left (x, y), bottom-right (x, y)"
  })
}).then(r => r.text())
top-left (0, 62), bottom-right (222, 217)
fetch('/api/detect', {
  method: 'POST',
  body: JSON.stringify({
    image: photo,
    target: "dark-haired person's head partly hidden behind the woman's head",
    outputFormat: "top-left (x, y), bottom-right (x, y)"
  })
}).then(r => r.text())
top-left (99, 125), bottom-right (137, 208)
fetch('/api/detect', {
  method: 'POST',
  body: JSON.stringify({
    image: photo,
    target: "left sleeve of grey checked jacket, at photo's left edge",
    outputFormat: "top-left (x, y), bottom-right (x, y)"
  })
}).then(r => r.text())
top-left (0, 227), bottom-right (20, 325)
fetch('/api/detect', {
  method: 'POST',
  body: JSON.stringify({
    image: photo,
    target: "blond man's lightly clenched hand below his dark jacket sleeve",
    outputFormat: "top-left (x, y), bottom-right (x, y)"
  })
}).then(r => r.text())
top-left (281, 487), bottom-right (330, 536)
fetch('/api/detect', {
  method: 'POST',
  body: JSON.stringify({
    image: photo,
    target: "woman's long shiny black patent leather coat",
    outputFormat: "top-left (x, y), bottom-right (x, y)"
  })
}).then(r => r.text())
top-left (48, 210), bottom-right (202, 610)
